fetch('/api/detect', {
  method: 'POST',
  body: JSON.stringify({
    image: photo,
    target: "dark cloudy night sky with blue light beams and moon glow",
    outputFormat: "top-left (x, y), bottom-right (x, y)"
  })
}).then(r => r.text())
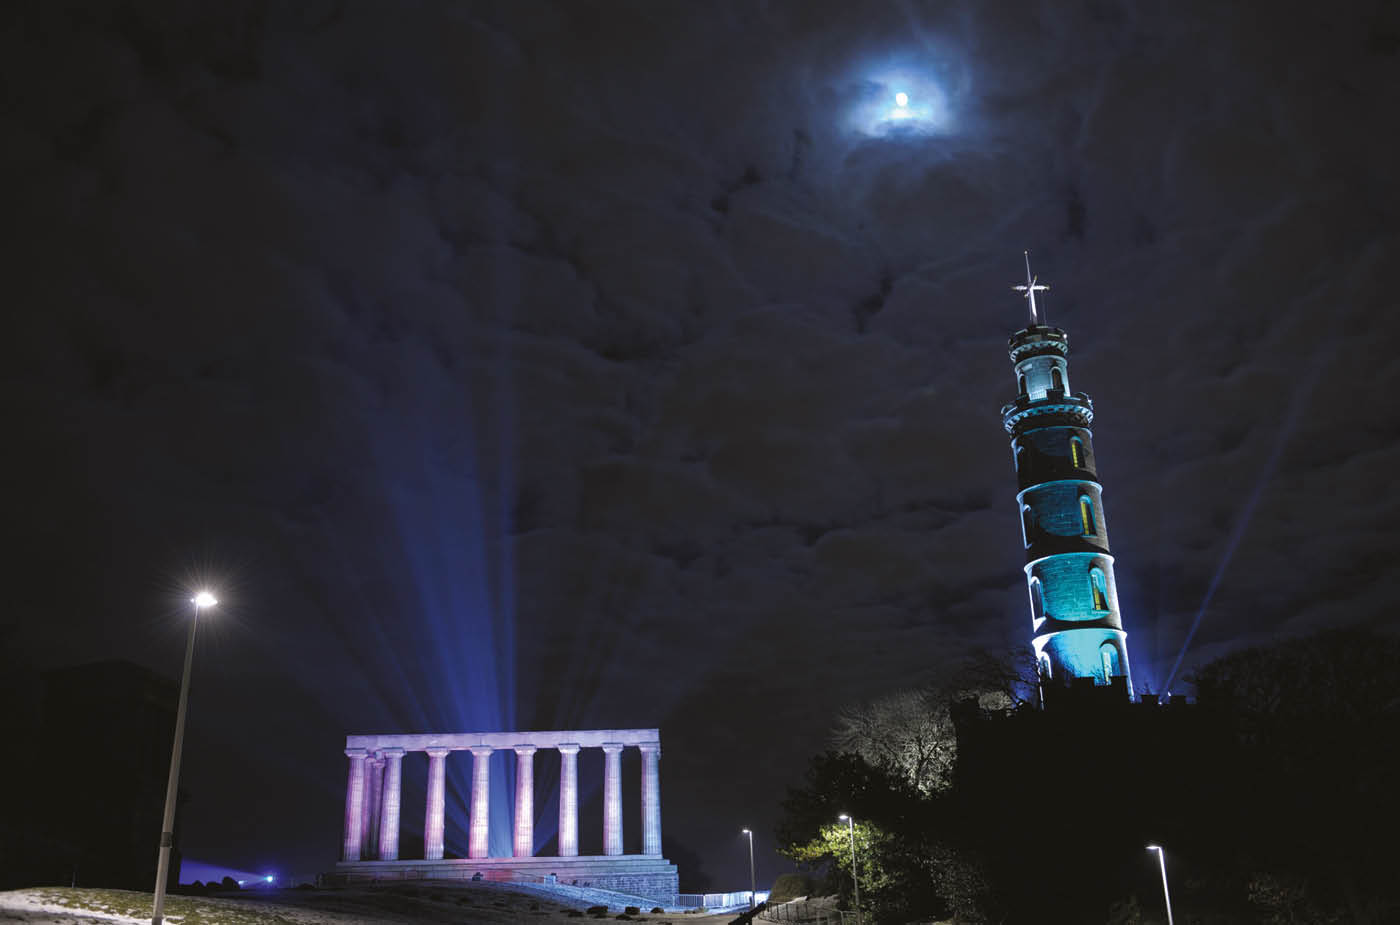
top-left (0, 0), bottom-right (1400, 890)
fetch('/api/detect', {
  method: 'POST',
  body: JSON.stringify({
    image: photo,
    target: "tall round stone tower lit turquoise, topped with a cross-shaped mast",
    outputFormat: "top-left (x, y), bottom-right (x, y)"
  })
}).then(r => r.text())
top-left (1001, 256), bottom-right (1133, 695)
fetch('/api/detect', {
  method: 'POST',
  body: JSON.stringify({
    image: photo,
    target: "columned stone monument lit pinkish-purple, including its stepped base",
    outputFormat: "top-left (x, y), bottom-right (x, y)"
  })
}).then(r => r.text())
top-left (333, 729), bottom-right (678, 903)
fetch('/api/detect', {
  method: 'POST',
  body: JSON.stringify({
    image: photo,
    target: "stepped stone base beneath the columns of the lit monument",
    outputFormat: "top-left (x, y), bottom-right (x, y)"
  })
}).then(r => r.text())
top-left (325, 855), bottom-right (680, 905)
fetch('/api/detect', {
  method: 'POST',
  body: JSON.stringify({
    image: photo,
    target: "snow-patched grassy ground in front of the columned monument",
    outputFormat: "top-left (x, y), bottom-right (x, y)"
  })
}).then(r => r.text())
top-left (0, 883), bottom-right (734, 925)
